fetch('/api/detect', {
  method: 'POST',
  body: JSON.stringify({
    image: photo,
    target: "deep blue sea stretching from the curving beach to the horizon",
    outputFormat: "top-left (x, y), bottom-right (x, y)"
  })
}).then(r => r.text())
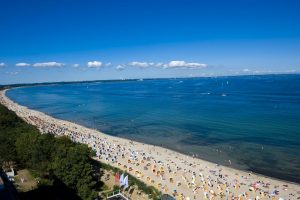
top-left (7, 75), bottom-right (300, 183)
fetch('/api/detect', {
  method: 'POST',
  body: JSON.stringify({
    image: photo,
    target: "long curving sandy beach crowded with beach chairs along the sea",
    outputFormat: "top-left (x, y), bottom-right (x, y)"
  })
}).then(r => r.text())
top-left (0, 90), bottom-right (300, 200)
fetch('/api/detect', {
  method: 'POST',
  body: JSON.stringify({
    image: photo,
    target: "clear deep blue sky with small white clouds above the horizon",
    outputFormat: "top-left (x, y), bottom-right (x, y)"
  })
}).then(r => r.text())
top-left (0, 0), bottom-right (300, 84)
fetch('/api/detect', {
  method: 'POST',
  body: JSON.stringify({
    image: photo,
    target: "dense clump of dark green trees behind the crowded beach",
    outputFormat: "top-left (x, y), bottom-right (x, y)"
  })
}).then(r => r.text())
top-left (0, 104), bottom-right (97, 200)
